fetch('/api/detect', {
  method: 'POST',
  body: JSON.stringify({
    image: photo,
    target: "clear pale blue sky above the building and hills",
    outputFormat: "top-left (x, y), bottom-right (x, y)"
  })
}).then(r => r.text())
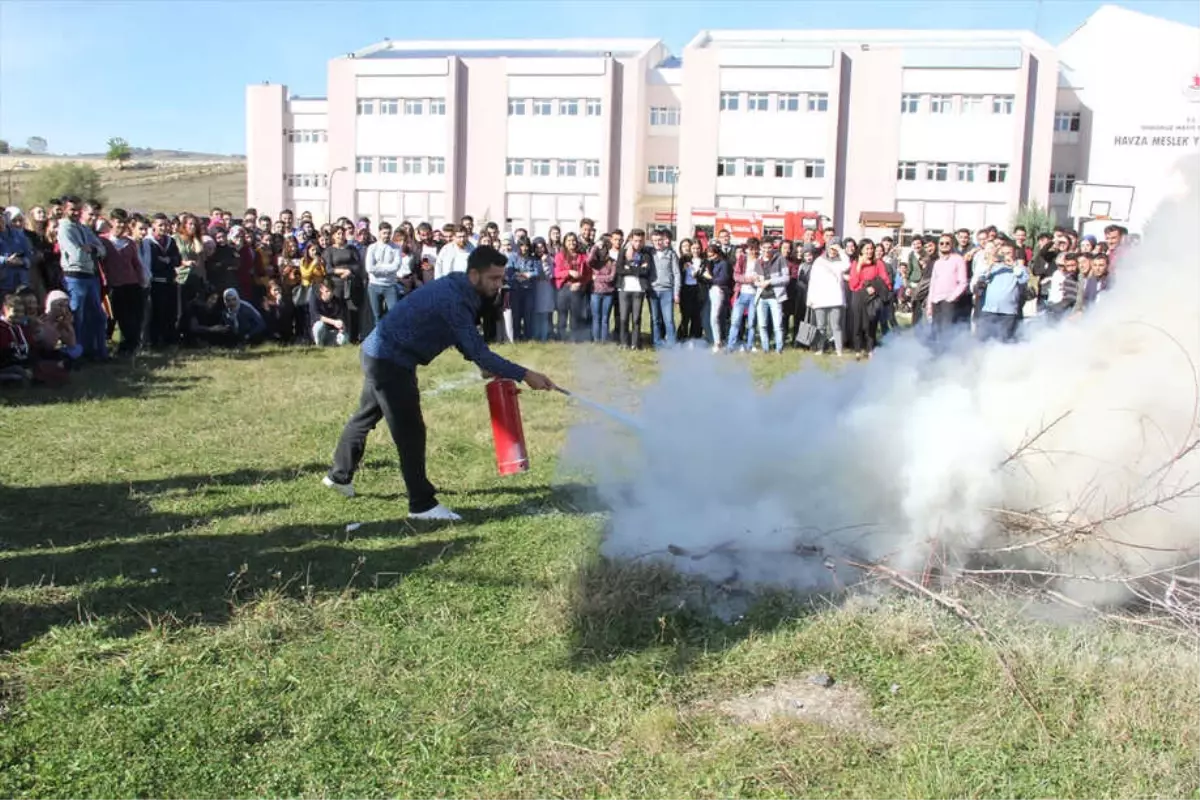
top-left (0, 0), bottom-right (1200, 154)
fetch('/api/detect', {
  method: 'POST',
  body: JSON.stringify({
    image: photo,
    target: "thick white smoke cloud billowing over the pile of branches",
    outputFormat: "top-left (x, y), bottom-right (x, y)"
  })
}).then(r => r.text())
top-left (563, 161), bottom-right (1200, 600)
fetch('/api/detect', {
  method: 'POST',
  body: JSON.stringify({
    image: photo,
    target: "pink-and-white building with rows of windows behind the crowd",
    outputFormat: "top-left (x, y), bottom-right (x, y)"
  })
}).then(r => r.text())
top-left (246, 31), bottom-right (1058, 241)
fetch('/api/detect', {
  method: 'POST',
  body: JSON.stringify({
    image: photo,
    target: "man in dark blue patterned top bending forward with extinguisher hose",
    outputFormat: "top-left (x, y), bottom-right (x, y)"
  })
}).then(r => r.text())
top-left (322, 246), bottom-right (554, 522)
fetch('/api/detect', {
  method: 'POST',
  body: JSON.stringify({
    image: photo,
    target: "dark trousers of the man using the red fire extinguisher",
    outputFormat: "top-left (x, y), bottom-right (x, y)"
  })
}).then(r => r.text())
top-left (329, 355), bottom-right (438, 513)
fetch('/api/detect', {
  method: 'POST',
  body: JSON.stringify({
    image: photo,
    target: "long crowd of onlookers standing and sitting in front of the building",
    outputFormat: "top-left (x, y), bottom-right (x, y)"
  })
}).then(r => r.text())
top-left (0, 197), bottom-right (1132, 384)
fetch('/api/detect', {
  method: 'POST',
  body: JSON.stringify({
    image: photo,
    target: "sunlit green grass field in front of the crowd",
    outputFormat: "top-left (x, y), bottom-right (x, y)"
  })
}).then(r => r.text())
top-left (0, 347), bottom-right (1200, 798)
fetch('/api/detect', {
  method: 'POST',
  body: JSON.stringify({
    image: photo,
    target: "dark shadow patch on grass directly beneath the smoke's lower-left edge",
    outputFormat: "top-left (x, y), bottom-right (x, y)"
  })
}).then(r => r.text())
top-left (568, 558), bottom-right (815, 673)
